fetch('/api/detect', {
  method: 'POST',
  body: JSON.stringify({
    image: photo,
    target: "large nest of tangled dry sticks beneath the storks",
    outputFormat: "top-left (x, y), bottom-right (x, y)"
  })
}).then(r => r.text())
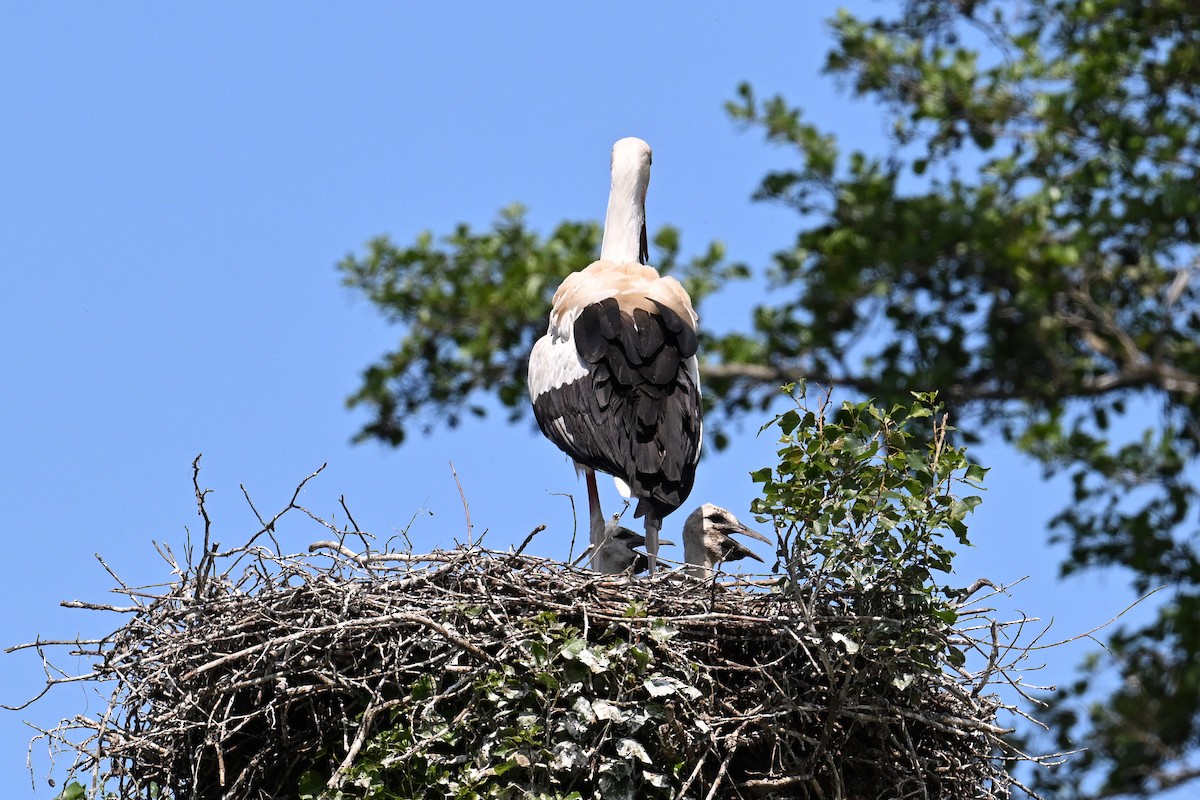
top-left (14, 472), bottom-right (1046, 800)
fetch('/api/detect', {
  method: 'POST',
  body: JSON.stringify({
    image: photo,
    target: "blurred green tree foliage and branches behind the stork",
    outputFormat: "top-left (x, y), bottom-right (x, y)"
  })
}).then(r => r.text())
top-left (341, 0), bottom-right (1200, 798)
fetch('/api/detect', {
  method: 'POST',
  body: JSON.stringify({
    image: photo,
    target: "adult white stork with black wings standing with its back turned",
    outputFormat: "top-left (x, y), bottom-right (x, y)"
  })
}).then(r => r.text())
top-left (529, 138), bottom-right (703, 575)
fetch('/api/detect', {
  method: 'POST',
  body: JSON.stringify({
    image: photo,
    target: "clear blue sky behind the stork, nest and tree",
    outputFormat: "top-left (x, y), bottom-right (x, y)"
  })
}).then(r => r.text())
top-left (0, 0), bottom-right (1161, 798)
